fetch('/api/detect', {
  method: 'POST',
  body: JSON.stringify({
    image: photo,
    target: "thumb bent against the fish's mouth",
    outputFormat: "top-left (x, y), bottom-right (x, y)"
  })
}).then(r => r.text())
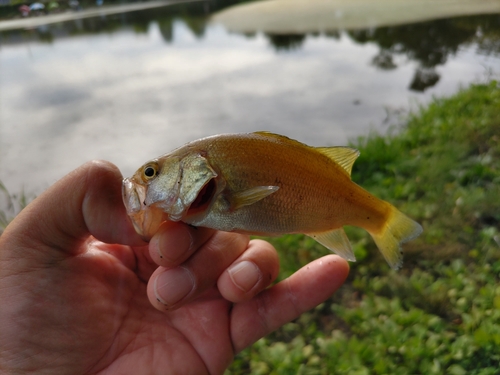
top-left (0, 161), bottom-right (144, 253)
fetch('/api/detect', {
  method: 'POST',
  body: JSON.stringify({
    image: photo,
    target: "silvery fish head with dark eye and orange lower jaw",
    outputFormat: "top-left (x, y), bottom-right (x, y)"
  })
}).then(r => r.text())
top-left (122, 153), bottom-right (217, 239)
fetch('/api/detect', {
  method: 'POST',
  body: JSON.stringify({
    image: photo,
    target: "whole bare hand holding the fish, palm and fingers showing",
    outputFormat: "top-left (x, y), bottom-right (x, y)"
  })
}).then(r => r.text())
top-left (0, 162), bottom-right (349, 375)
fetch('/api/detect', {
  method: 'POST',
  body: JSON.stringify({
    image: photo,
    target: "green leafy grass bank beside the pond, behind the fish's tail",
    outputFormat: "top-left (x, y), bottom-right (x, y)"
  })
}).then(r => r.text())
top-left (227, 82), bottom-right (500, 375)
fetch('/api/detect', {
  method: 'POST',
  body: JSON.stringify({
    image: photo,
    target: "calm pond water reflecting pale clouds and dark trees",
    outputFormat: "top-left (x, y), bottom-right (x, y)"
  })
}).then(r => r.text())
top-left (0, 1), bottom-right (500, 198)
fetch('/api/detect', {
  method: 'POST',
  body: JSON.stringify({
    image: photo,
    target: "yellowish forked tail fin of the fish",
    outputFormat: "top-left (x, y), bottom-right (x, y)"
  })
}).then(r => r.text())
top-left (370, 206), bottom-right (422, 270)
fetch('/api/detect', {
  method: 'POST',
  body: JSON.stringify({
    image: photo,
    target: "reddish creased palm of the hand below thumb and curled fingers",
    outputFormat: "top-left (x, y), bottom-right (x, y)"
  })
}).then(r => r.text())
top-left (2, 240), bottom-right (232, 374)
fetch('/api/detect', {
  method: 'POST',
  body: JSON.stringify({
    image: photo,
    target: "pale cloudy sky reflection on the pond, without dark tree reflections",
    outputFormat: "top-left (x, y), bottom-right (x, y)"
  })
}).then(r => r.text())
top-left (0, 21), bottom-right (498, 197)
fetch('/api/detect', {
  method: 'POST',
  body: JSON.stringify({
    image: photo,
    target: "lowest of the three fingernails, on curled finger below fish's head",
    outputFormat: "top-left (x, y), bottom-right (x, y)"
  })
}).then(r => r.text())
top-left (154, 267), bottom-right (194, 307)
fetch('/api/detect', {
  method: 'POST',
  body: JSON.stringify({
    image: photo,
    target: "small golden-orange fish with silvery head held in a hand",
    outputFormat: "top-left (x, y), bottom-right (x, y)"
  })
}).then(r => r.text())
top-left (122, 131), bottom-right (422, 269)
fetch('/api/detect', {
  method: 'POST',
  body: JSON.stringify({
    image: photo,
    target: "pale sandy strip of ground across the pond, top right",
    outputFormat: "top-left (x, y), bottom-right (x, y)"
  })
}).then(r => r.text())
top-left (212, 0), bottom-right (500, 34)
